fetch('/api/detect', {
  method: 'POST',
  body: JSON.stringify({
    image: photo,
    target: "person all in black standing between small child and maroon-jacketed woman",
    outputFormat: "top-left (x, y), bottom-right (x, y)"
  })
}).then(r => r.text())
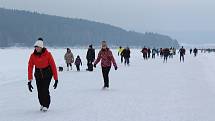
top-left (86, 45), bottom-right (95, 71)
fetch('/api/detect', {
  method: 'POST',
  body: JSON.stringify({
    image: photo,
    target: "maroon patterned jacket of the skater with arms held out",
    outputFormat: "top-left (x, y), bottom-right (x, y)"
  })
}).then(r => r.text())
top-left (94, 48), bottom-right (117, 67)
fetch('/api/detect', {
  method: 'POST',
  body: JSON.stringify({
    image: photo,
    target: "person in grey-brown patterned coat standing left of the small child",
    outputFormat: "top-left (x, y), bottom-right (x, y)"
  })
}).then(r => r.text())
top-left (64, 48), bottom-right (74, 71)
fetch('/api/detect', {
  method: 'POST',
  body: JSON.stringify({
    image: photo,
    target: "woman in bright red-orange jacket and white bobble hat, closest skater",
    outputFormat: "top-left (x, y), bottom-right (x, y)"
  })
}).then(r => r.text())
top-left (28, 38), bottom-right (58, 112)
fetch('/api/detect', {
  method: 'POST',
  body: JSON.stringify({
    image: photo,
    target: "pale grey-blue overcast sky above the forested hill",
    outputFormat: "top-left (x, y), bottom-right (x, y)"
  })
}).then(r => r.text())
top-left (0, 0), bottom-right (215, 44)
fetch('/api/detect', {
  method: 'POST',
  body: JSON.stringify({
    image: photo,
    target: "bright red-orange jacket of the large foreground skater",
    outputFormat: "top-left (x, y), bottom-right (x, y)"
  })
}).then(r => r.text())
top-left (28, 49), bottom-right (58, 80)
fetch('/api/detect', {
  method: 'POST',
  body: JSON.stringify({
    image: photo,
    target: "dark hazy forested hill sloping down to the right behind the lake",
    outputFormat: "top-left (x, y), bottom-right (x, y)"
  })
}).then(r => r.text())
top-left (0, 8), bottom-right (179, 48)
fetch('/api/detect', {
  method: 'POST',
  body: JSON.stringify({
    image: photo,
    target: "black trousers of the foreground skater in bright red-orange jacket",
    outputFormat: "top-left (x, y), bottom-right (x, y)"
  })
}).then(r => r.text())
top-left (34, 67), bottom-right (52, 108)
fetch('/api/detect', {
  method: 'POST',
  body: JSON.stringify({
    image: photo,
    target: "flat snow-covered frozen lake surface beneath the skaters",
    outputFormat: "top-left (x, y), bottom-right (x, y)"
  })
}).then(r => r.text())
top-left (0, 48), bottom-right (215, 121)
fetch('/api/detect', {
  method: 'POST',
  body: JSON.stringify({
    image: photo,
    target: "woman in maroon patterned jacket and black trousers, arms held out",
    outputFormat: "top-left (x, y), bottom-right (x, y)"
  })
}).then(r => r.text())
top-left (94, 41), bottom-right (117, 89)
